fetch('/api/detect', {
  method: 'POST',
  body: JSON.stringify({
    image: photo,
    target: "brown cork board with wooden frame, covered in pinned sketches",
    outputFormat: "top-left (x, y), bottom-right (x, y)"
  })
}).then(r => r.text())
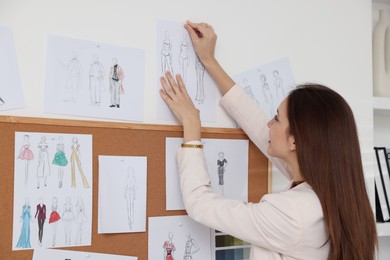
top-left (0, 116), bottom-right (270, 260)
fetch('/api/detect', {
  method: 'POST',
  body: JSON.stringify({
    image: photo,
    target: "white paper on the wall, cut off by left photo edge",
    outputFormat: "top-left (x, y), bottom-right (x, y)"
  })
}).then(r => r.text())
top-left (0, 27), bottom-right (24, 110)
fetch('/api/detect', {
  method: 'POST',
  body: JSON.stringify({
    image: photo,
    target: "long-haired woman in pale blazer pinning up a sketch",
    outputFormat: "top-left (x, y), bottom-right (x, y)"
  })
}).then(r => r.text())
top-left (160, 22), bottom-right (377, 260)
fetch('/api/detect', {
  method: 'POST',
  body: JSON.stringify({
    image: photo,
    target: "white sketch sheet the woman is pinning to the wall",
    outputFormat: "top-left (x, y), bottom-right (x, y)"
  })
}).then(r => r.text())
top-left (156, 20), bottom-right (218, 122)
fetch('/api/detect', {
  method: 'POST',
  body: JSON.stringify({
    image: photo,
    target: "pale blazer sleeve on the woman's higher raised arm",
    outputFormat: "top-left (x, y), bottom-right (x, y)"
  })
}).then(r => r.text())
top-left (220, 84), bottom-right (292, 180)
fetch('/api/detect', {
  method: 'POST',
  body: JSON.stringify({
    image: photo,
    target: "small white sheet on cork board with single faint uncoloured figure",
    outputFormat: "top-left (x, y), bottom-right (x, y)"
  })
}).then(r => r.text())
top-left (98, 155), bottom-right (147, 233)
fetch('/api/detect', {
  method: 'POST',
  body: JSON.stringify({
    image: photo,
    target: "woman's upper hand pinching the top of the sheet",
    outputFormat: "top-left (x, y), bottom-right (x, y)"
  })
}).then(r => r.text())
top-left (184, 21), bottom-right (217, 67)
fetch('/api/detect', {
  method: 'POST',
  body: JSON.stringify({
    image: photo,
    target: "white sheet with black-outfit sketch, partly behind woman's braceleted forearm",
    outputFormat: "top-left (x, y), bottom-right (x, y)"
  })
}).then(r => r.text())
top-left (165, 138), bottom-right (249, 210)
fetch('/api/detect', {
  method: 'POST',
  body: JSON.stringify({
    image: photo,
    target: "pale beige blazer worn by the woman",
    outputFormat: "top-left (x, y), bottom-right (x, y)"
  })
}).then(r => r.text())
top-left (177, 85), bottom-right (329, 260)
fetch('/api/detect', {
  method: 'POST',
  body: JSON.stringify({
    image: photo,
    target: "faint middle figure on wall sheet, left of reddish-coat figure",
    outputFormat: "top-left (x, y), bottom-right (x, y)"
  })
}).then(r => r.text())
top-left (89, 55), bottom-right (104, 106)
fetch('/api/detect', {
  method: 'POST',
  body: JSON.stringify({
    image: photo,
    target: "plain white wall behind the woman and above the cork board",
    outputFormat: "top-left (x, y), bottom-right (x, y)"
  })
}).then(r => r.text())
top-left (0, 0), bottom-right (385, 259)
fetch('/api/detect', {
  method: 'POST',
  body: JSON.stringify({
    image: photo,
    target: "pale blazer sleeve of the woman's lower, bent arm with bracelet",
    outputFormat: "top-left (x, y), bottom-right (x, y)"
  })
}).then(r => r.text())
top-left (177, 148), bottom-right (302, 252)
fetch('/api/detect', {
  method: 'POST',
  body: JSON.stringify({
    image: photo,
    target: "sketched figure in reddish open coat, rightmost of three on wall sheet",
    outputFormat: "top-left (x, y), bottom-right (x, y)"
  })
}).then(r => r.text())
top-left (109, 58), bottom-right (125, 108)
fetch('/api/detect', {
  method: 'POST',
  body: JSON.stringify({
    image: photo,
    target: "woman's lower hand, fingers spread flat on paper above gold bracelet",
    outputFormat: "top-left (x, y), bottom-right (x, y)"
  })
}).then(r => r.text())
top-left (160, 72), bottom-right (201, 142)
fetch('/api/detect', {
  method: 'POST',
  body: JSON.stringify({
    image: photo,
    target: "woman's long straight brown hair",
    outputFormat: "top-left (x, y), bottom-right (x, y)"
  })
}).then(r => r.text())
top-left (287, 84), bottom-right (378, 260)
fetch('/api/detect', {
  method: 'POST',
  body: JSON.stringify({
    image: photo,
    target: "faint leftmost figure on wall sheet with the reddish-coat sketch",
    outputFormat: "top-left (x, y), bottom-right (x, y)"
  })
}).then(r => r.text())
top-left (62, 52), bottom-right (82, 103)
